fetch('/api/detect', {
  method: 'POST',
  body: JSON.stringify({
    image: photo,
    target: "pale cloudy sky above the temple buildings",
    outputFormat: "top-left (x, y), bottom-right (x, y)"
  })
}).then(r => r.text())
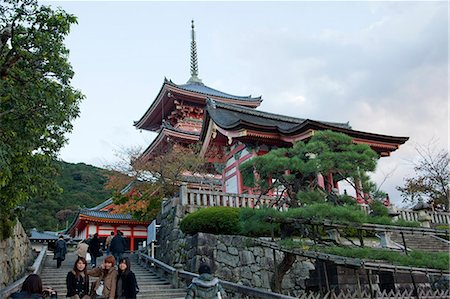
top-left (44, 1), bottom-right (449, 203)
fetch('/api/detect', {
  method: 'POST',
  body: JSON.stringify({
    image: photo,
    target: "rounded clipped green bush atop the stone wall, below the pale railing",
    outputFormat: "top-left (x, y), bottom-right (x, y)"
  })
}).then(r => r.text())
top-left (180, 207), bottom-right (240, 235)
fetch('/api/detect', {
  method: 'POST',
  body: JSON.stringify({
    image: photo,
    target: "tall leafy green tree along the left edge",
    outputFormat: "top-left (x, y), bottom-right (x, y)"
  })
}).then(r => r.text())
top-left (0, 0), bottom-right (83, 239)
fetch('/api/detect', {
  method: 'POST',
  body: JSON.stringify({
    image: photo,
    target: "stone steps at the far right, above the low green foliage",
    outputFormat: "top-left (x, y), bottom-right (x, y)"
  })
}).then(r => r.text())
top-left (391, 233), bottom-right (450, 252)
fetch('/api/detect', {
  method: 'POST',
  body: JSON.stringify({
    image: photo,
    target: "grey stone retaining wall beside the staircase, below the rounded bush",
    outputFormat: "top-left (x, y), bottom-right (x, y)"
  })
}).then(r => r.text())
top-left (156, 206), bottom-right (314, 293)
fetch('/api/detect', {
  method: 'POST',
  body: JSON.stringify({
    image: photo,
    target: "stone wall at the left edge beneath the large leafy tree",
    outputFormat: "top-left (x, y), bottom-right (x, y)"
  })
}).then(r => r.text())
top-left (0, 222), bottom-right (33, 289)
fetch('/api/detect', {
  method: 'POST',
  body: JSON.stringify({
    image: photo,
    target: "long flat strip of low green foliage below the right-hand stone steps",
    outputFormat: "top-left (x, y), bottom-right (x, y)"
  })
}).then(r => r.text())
top-left (316, 246), bottom-right (449, 270)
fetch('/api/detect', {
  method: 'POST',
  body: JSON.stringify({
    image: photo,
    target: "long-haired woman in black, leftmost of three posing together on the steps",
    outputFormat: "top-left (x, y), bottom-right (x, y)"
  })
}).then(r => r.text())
top-left (66, 256), bottom-right (91, 299)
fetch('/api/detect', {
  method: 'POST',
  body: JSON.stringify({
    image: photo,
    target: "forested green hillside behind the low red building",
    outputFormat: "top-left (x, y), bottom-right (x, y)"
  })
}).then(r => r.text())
top-left (20, 161), bottom-right (111, 231)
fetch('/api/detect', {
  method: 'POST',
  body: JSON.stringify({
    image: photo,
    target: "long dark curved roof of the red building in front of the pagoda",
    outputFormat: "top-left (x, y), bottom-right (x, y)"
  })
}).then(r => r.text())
top-left (200, 99), bottom-right (409, 156)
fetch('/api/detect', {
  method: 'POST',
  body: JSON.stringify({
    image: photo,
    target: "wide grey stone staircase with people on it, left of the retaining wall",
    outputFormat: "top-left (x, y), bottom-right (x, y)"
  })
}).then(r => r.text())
top-left (41, 253), bottom-right (186, 299)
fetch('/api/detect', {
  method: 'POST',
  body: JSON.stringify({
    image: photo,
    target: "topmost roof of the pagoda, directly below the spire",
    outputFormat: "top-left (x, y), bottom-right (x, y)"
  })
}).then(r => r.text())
top-left (134, 78), bottom-right (262, 131)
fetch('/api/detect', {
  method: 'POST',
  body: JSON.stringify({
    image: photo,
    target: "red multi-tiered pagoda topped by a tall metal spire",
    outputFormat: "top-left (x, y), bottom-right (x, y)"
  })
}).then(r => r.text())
top-left (134, 21), bottom-right (262, 162)
